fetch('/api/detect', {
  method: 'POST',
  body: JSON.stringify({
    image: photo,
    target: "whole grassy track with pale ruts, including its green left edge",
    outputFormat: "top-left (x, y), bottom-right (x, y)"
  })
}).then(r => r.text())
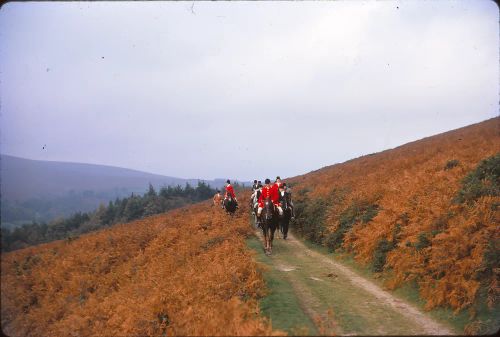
top-left (249, 233), bottom-right (455, 335)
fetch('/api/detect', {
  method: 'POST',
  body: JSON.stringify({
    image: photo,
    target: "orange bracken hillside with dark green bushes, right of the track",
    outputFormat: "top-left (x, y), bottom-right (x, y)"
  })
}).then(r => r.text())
top-left (288, 118), bottom-right (500, 330)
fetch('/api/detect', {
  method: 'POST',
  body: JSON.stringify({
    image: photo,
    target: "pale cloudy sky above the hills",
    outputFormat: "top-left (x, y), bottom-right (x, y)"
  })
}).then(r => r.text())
top-left (0, 0), bottom-right (499, 180)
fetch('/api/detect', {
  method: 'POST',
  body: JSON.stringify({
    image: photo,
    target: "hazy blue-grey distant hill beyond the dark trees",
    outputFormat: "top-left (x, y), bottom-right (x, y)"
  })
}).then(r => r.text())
top-left (0, 155), bottom-right (242, 225)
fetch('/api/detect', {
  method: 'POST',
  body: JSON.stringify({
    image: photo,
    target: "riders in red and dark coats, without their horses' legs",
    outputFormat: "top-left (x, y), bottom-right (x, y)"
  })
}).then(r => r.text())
top-left (213, 176), bottom-right (295, 226)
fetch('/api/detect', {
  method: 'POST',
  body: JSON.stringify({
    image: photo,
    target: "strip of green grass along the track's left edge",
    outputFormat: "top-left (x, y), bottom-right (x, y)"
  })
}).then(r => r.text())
top-left (247, 237), bottom-right (318, 335)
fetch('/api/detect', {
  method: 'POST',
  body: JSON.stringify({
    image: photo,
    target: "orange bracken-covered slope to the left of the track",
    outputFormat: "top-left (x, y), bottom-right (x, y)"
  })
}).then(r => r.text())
top-left (1, 203), bottom-right (280, 336)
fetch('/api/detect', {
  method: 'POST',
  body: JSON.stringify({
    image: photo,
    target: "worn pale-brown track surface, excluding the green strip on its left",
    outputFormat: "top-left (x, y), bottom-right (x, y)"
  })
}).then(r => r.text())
top-left (258, 231), bottom-right (456, 335)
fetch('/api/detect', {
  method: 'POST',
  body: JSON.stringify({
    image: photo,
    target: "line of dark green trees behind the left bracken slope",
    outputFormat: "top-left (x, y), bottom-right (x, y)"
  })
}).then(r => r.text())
top-left (1, 181), bottom-right (222, 252)
